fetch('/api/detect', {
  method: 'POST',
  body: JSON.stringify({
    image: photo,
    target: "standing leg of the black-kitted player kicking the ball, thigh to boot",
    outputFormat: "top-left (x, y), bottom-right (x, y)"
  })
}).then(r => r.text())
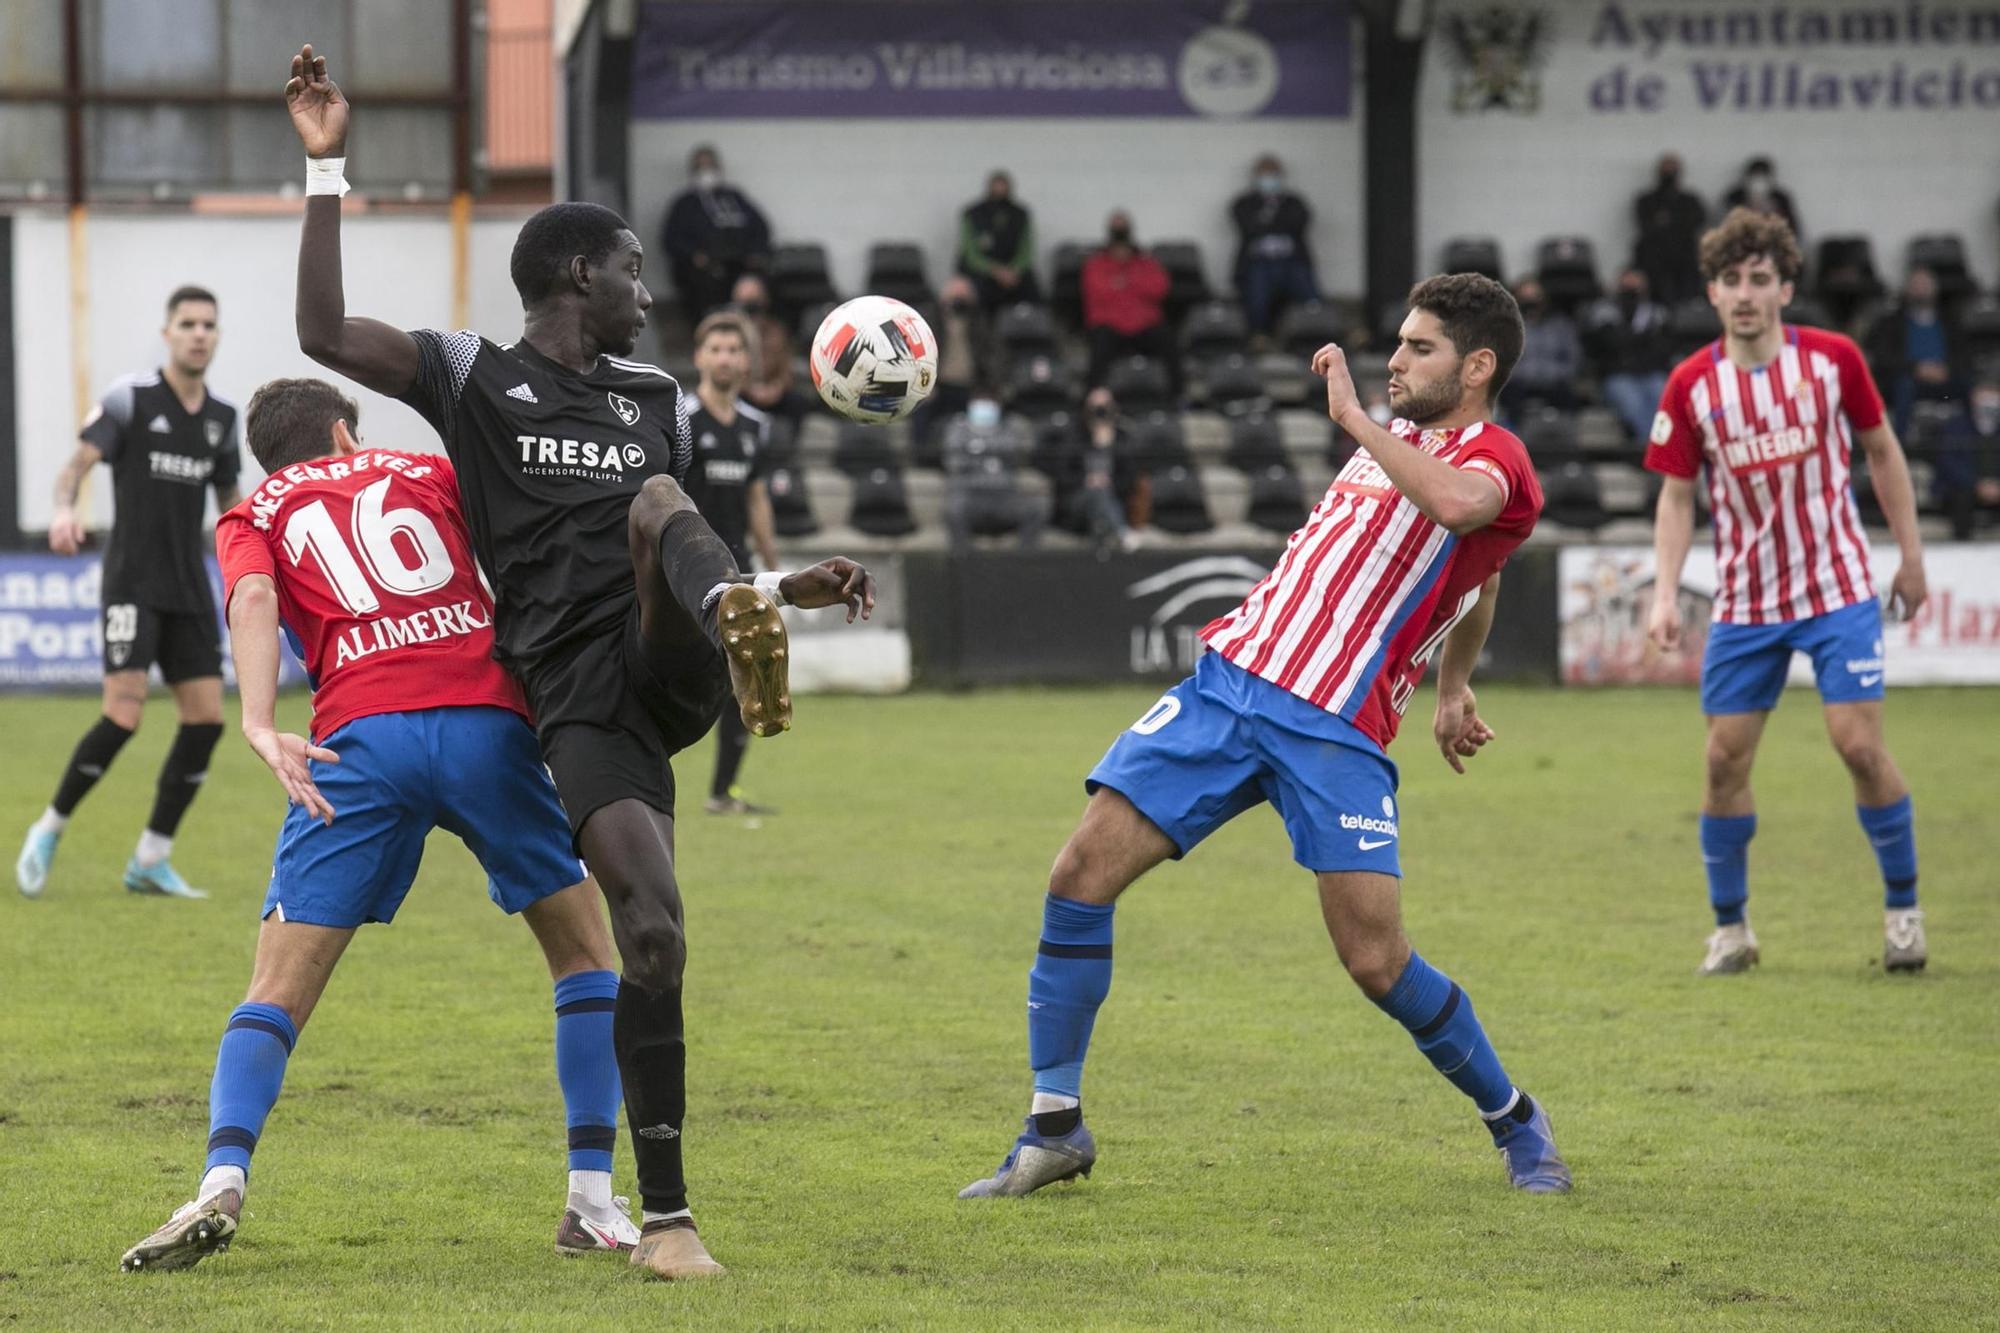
top-left (578, 799), bottom-right (724, 1281)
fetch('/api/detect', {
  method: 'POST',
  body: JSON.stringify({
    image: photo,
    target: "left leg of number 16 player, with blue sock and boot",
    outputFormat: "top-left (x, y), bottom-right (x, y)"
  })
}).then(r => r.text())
top-left (118, 921), bottom-right (354, 1273)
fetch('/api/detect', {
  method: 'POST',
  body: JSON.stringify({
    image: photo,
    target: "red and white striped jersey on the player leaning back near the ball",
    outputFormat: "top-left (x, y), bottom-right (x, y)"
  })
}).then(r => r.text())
top-left (1202, 418), bottom-right (1542, 749)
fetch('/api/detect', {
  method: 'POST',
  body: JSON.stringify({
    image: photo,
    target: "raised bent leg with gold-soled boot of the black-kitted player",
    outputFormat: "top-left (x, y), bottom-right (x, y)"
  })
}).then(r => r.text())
top-left (630, 476), bottom-right (792, 737)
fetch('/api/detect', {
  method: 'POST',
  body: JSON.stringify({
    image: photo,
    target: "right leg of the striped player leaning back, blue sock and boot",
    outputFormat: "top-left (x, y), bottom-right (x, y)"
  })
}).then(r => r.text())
top-left (1320, 871), bottom-right (1570, 1195)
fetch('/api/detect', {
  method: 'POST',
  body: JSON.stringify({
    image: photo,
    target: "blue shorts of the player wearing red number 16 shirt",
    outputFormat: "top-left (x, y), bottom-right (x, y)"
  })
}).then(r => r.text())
top-left (264, 707), bottom-right (584, 927)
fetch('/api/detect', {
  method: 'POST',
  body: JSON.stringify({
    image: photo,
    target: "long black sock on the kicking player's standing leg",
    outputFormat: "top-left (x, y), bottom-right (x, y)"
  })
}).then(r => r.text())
top-left (612, 977), bottom-right (688, 1213)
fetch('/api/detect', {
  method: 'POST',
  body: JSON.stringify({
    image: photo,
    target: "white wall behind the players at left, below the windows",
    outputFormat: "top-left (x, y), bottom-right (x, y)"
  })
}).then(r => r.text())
top-left (14, 212), bottom-right (526, 530)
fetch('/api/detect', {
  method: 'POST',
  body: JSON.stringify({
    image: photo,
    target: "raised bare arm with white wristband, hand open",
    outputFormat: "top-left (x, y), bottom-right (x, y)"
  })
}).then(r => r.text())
top-left (284, 46), bottom-right (418, 396)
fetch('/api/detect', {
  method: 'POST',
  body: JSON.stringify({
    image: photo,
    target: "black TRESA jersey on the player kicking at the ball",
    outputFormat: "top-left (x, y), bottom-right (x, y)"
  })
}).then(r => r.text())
top-left (404, 328), bottom-right (694, 673)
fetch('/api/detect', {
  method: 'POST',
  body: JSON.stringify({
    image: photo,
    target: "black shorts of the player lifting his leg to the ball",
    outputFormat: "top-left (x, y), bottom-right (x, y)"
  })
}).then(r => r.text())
top-left (522, 600), bottom-right (730, 835)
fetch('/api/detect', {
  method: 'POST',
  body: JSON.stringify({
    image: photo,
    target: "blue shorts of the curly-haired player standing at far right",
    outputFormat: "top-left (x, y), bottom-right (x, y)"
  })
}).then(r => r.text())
top-left (1702, 598), bottom-right (1882, 717)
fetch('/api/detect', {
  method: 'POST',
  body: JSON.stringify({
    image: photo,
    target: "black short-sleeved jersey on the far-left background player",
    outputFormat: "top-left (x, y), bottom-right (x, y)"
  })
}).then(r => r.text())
top-left (78, 370), bottom-right (242, 610)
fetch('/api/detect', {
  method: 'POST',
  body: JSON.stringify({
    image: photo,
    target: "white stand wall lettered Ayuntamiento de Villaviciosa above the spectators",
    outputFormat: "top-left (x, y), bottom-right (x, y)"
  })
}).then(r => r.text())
top-left (1418, 0), bottom-right (2000, 286)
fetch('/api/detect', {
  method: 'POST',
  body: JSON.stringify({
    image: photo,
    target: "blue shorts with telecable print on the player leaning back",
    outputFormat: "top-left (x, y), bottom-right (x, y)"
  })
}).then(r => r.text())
top-left (1084, 652), bottom-right (1402, 877)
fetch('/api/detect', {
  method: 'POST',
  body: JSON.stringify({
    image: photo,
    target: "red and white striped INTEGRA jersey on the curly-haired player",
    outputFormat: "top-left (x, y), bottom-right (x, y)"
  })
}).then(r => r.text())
top-left (1646, 326), bottom-right (1882, 624)
